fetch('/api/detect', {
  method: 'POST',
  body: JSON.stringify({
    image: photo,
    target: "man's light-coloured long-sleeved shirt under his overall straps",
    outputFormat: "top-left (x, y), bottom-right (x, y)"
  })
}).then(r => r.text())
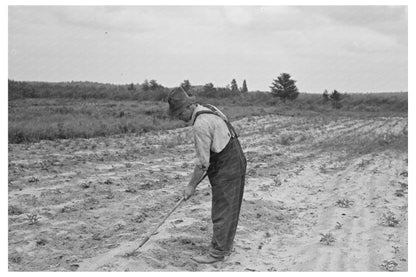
top-left (191, 104), bottom-right (231, 170)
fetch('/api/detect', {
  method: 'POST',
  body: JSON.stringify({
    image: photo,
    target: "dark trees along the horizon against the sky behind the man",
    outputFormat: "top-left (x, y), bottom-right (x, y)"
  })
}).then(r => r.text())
top-left (8, 73), bottom-right (348, 104)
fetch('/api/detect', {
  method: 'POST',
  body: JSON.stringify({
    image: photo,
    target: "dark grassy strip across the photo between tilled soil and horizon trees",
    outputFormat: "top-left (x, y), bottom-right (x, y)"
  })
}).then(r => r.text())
top-left (8, 83), bottom-right (408, 143)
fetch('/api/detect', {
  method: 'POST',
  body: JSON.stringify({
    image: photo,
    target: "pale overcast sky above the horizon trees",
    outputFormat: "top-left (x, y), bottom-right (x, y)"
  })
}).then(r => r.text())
top-left (8, 6), bottom-right (408, 93)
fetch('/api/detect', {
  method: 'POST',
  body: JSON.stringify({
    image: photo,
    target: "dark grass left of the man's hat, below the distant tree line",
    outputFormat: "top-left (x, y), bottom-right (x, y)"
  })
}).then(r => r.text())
top-left (9, 99), bottom-right (185, 143)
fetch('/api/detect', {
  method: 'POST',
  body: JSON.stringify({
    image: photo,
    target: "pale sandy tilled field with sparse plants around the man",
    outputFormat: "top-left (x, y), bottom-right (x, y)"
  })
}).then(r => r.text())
top-left (8, 115), bottom-right (408, 271)
